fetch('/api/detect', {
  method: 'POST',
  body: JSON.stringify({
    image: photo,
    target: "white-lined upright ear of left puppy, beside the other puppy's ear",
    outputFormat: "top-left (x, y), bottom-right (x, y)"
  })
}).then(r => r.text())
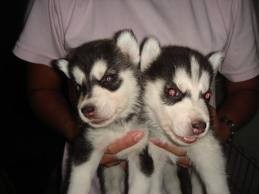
top-left (115, 30), bottom-right (140, 65)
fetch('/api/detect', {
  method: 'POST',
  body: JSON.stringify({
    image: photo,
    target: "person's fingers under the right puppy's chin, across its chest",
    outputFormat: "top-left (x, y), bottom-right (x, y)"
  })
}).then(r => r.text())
top-left (150, 139), bottom-right (191, 168)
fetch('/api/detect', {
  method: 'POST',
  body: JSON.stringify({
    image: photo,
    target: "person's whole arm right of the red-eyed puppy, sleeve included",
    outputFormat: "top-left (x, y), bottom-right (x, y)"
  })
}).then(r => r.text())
top-left (214, 0), bottom-right (259, 142)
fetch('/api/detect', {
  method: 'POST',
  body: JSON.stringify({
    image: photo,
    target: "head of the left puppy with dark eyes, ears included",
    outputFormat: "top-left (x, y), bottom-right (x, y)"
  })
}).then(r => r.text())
top-left (55, 30), bottom-right (140, 128)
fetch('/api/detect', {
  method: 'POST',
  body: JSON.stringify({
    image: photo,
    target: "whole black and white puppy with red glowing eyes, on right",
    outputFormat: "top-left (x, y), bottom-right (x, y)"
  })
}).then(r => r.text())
top-left (140, 37), bottom-right (229, 194)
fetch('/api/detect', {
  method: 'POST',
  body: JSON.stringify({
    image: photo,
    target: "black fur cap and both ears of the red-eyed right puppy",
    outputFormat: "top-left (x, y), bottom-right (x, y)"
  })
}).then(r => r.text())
top-left (140, 37), bottom-right (223, 85)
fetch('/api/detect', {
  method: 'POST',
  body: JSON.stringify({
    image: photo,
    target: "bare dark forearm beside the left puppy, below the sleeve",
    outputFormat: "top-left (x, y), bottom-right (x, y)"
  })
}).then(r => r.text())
top-left (27, 64), bottom-right (79, 141)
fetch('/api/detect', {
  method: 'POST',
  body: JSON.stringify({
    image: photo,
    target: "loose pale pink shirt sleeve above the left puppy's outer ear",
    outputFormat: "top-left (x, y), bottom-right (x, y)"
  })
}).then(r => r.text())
top-left (13, 0), bottom-right (69, 65)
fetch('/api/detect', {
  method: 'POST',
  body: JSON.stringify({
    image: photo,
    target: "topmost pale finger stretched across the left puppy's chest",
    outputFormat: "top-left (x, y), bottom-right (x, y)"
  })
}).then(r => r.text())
top-left (105, 130), bottom-right (144, 154)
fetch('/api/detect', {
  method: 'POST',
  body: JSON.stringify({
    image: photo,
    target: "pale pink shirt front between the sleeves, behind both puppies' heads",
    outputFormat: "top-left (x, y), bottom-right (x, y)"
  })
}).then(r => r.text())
top-left (58, 0), bottom-right (228, 54)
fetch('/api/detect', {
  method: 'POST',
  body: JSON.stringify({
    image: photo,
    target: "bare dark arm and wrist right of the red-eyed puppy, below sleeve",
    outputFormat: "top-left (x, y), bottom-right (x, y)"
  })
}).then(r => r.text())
top-left (212, 76), bottom-right (259, 142)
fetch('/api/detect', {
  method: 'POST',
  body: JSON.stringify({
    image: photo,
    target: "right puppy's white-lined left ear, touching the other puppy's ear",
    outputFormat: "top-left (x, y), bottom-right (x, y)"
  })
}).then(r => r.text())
top-left (140, 37), bottom-right (161, 72)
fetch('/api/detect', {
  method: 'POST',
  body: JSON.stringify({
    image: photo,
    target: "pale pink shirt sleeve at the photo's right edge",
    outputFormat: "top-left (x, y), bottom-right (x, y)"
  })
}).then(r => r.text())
top-left (220, 0), bottom-right (259, 82)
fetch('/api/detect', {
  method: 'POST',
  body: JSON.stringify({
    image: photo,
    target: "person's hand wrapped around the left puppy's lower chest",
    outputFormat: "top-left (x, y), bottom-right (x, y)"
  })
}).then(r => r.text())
top-left (100, 130), bottom-right (144, 167)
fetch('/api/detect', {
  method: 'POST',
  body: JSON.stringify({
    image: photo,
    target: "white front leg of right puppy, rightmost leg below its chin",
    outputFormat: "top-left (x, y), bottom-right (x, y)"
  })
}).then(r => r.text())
top-left (188, 133), bottom-right (230, 194)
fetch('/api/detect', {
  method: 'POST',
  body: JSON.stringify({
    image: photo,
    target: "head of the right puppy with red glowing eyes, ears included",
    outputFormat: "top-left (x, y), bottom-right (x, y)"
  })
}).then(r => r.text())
top-left (140, 38), bottom-right (223, 145)
